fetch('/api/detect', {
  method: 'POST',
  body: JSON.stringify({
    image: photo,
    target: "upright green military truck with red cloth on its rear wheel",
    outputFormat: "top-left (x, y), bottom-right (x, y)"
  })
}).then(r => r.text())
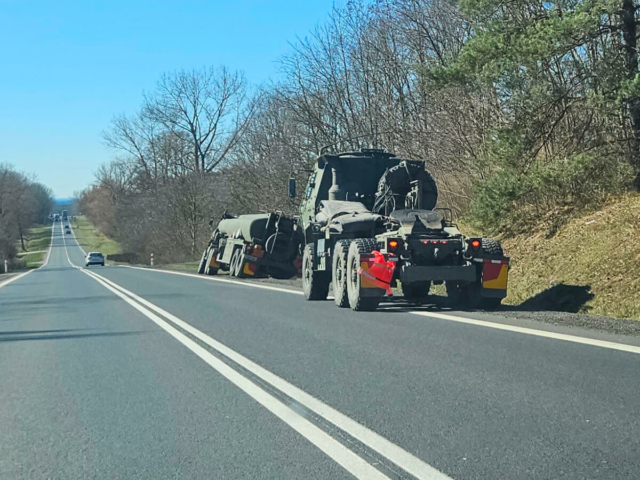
top-left (290, 149), bottom-right (509, 310)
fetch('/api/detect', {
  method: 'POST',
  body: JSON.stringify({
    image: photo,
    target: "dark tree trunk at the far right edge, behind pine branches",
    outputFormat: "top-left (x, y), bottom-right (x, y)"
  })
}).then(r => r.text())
top-left (621, 0), bottom-right (640, 190)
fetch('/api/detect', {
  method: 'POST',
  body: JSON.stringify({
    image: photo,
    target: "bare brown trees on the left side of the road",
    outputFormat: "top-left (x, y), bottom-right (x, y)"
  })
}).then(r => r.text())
top-left (0, 164), bottom-right (54, 268)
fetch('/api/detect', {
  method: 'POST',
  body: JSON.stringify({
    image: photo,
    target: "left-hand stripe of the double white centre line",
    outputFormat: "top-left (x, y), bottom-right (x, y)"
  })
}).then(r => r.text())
top-left (74, 265), bottom-right (392, 480)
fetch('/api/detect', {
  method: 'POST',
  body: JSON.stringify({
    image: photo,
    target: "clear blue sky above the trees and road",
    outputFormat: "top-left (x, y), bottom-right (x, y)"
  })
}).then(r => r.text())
top-left (0, 0), bottom-right (344, 198)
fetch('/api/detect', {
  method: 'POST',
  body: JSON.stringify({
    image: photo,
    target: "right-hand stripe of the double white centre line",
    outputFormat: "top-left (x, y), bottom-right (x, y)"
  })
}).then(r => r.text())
top-left (83, 270), bottom-right (449, 480)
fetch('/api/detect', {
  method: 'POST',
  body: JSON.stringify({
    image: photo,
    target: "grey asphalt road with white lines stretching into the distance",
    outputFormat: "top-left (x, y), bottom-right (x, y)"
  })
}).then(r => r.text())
top-left (0, 223), bottom-right (640, 479)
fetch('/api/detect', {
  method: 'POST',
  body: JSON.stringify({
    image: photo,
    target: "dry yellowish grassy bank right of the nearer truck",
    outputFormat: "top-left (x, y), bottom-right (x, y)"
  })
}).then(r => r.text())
top-left (502, 195), bottom-right (640, 319)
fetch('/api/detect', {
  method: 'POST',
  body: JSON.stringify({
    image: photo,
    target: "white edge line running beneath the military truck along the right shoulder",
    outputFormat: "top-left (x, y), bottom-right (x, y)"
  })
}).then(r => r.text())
top-left (129, 265), bottom-right (640, 353)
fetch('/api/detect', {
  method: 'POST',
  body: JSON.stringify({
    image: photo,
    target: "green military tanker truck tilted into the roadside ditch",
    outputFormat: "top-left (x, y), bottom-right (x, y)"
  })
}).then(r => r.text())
top-left (198, 212), bottom-right (302, 279)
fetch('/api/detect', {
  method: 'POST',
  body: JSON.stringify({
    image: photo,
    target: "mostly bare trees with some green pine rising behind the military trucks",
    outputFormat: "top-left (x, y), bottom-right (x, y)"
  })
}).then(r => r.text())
top-left (81, 0), bottom-right (640, 261)
